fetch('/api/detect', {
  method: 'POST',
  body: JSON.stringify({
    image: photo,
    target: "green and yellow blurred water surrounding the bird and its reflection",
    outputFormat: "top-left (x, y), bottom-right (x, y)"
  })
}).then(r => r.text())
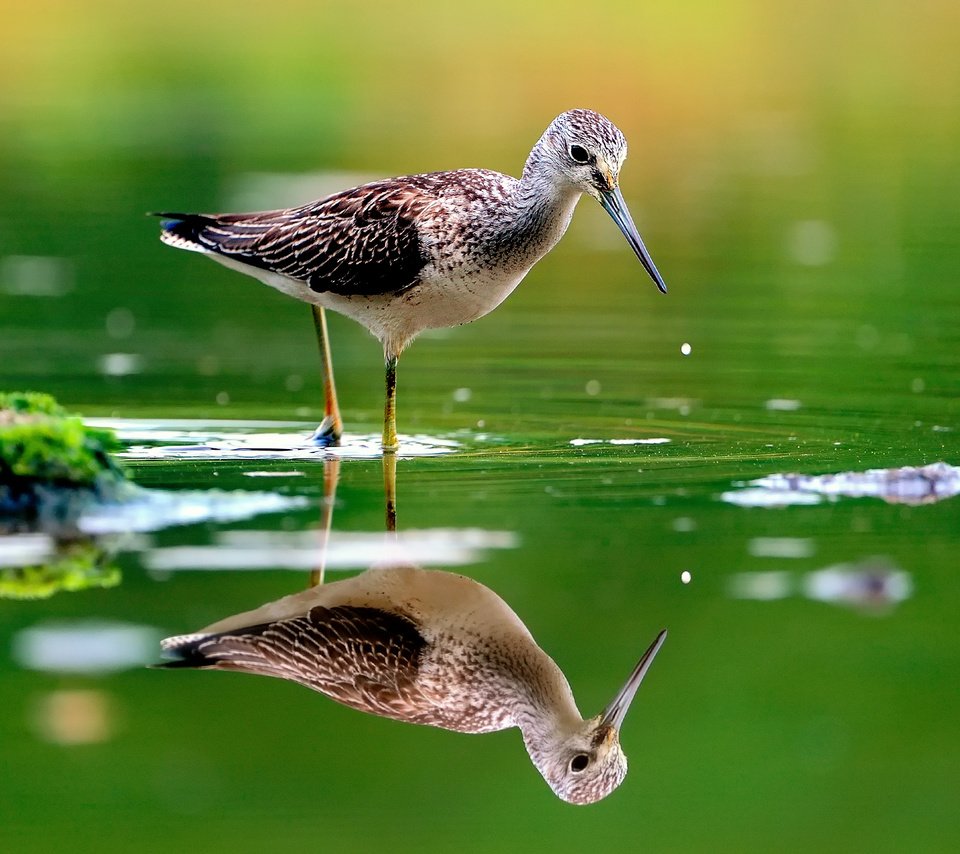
top-left (0, 2), bottom-right (960, 852)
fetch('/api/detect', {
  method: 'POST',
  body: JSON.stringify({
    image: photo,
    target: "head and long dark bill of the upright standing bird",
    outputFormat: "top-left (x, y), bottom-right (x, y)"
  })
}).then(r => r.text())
top-left (541, 110), bottom-right (667, 293)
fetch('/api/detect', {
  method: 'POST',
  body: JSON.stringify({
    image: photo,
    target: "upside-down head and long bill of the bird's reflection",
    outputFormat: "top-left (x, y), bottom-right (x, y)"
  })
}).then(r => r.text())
top-left (531, 630), bottom-right (667, 804)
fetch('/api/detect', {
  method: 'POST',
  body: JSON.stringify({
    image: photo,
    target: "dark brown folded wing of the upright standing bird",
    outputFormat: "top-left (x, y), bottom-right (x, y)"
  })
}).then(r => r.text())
top-left (160, 173), bottom-right (444, 296)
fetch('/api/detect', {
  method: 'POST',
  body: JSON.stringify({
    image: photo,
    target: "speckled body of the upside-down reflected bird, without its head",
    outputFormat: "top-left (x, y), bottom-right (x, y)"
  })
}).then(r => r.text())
top-left (163, 568), bottom-right (560, 733)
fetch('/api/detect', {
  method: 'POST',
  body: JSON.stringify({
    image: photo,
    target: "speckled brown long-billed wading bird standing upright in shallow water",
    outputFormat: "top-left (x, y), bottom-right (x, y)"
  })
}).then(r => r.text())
top-left (156, 109), bottom-right (667, 452)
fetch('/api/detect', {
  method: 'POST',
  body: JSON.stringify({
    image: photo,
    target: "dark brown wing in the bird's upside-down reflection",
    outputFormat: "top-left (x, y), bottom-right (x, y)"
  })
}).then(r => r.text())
top-left (163, 605), bottom-right (442, 725)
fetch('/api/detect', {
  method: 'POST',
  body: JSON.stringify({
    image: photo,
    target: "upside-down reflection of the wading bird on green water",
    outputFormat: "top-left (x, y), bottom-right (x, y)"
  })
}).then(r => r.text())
top-left (159, 564), bottom-right (667, 804)
